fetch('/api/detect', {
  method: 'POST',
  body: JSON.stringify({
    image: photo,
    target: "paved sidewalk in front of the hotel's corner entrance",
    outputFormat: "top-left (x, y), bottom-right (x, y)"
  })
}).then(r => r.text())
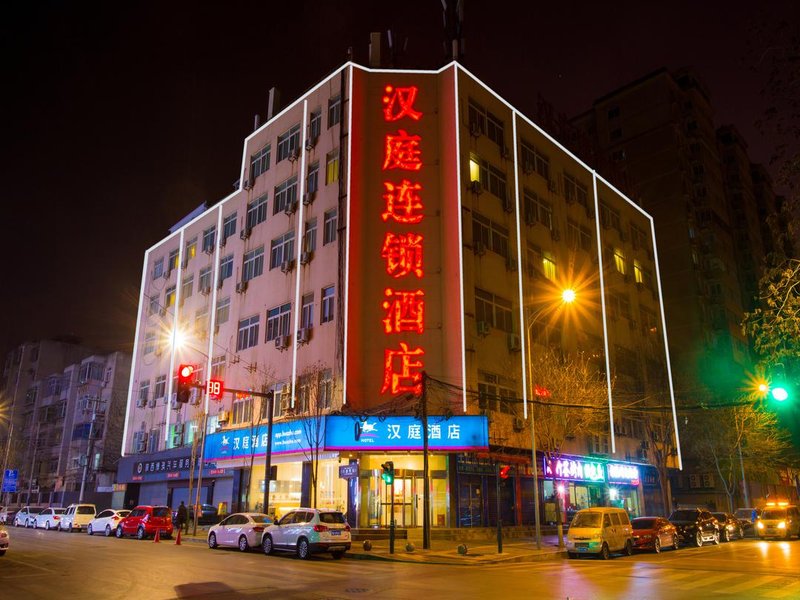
top-left (177, 527), bottom-right (566, 565)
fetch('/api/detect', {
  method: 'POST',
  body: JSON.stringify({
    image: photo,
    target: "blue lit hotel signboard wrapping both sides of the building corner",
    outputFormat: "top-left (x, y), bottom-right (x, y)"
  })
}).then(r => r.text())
top-left (205, 416), bottom-right (489, 461)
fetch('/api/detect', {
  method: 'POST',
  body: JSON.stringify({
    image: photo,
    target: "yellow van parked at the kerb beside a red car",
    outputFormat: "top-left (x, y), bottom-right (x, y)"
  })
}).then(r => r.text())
top-left (567, 506), bottom-right (633, 560)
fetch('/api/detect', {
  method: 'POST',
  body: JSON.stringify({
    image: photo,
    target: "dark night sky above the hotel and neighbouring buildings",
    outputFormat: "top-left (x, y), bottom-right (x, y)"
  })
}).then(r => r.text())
top-left (0, 0), bottom-right (800, 357)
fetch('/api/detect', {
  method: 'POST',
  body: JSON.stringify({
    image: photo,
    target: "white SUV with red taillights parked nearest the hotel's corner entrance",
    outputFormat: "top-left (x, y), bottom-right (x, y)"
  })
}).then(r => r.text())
top-left (261, 508), bottom-right (350, 560)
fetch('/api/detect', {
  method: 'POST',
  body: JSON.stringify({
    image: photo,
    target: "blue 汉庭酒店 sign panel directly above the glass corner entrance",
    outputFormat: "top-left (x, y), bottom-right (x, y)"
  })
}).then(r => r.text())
top-left (325, 416), bottom-right (489, 451)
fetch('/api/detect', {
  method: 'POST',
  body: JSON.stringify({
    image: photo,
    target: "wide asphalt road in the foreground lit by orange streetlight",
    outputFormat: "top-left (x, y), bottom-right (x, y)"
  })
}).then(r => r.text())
top-left (0, 528), bottom-right (800, 600)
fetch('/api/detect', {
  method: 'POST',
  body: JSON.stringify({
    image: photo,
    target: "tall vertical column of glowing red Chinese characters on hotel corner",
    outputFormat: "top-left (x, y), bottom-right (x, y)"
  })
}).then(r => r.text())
top-left (381, 85), bottom-right (425, 395)
